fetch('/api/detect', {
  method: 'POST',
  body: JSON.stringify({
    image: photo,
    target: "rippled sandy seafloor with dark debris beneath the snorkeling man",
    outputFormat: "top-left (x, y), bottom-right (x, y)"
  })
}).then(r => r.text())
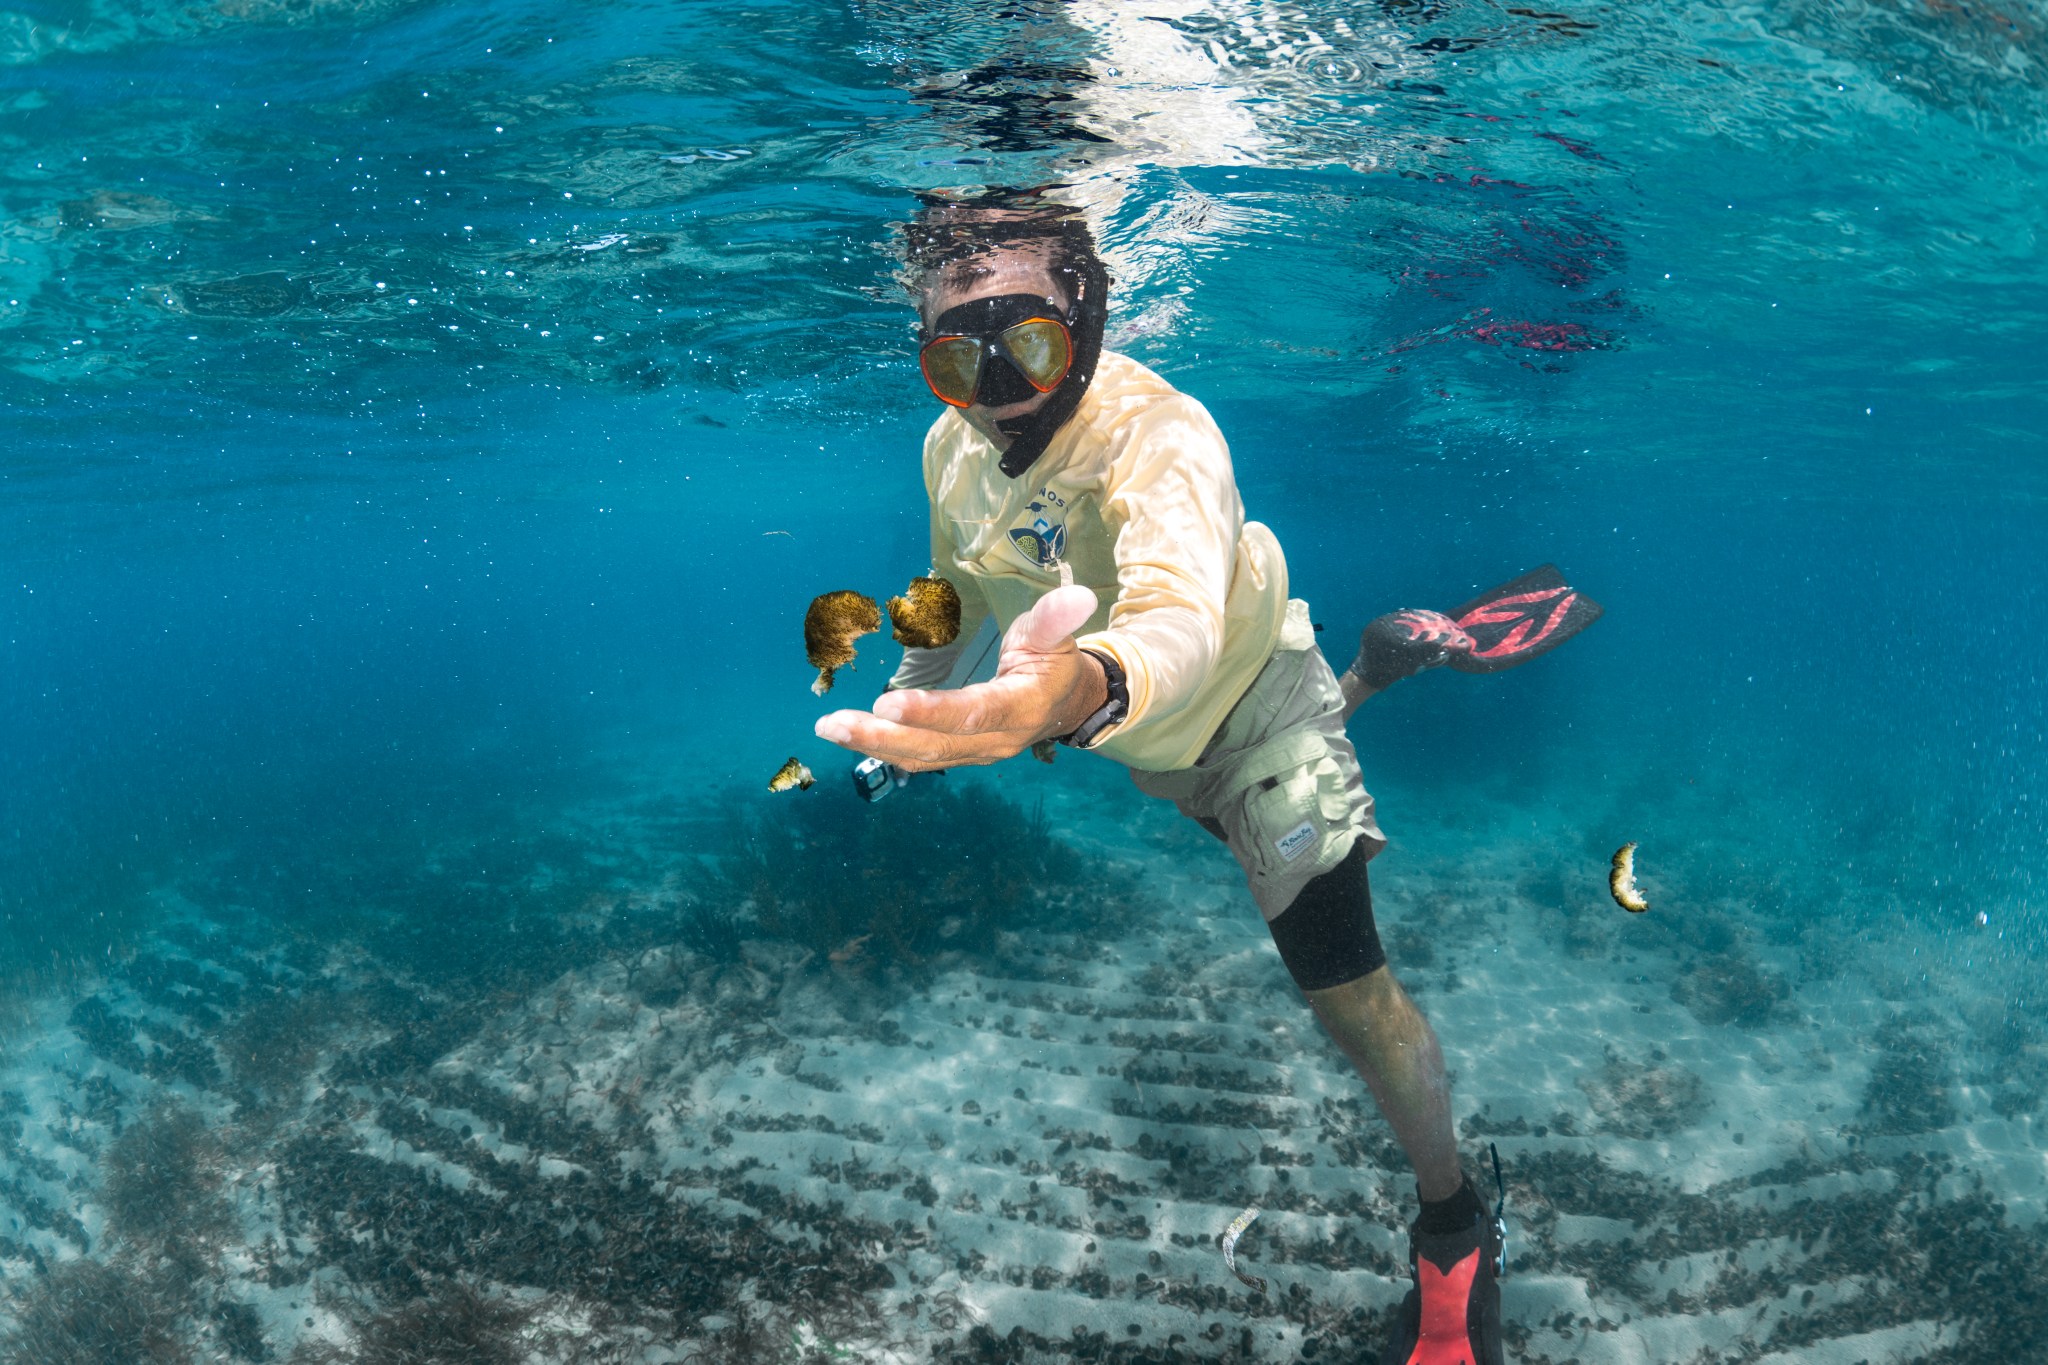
top-left (0, 759), bottom-right (2048, 1365)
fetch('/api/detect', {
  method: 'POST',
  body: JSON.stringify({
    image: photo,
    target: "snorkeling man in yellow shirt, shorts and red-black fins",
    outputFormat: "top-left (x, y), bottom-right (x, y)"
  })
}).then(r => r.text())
top-left (817, 192), bottom-right (1599, 1365)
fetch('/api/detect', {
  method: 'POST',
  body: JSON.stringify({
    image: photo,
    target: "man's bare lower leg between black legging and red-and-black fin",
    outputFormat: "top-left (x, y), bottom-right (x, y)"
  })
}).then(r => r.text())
top-left (1309, 966), bottom-right (1464, 1199)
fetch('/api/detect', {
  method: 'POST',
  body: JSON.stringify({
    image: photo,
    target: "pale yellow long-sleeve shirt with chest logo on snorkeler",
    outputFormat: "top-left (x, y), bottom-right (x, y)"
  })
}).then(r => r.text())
top-left (891, 352), bottom-right (1288, 772)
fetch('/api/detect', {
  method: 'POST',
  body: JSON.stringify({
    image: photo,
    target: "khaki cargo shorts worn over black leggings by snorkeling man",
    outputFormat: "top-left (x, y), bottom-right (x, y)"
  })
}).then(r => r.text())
top-left (1130, 600), bottom-right (1386, 921)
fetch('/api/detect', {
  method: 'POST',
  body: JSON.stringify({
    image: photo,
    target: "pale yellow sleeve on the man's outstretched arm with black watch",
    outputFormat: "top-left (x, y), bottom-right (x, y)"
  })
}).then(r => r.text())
top-left (1077, 395), bottom-right (1245, 735)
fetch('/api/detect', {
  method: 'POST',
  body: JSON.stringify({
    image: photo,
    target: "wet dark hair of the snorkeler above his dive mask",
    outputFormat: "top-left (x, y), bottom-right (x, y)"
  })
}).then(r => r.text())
top-left (901, 188), bottom-right (1110, 313)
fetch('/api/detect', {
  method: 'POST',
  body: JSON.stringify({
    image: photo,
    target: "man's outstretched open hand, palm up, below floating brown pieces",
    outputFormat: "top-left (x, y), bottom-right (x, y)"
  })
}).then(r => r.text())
top-left (817, 587), bottom-right (1108, 772)
